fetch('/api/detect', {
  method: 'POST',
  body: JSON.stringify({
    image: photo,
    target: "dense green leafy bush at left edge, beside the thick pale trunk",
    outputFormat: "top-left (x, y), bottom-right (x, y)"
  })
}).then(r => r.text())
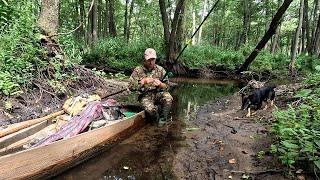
top-left (0, 0), bottom-right (42, 95)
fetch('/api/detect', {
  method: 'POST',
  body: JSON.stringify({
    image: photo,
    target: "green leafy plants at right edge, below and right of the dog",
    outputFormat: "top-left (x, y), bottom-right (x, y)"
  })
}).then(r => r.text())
top-left (271, 74), bottom-right (320, 169)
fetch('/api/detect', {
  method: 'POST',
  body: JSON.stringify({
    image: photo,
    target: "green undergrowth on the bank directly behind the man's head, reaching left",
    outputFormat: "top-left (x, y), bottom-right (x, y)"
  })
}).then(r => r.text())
top-left (83, 38), bottom-right (163, 69)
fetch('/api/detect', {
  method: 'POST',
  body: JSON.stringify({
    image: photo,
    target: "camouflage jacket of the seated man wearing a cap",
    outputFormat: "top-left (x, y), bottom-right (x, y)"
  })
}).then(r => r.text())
top-left (129, 65), bottom-right (169, 94)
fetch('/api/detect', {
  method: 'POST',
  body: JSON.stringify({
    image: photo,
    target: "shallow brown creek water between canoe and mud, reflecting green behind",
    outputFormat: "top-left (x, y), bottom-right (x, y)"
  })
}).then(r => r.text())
top-left (53, 78), bottom-right (238, 180)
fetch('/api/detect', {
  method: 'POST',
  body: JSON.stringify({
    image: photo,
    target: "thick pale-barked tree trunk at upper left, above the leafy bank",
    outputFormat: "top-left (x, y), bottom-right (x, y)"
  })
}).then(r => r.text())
top-left (38, 0), bottom-right (60, 36)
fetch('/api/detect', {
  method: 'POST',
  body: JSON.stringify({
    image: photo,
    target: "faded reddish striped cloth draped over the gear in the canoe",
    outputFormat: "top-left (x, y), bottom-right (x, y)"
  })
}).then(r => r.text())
top-left (32, 102), bottom-right (103, 147)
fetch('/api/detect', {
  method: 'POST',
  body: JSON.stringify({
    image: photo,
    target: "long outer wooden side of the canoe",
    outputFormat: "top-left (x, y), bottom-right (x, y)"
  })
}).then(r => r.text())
top-left (0, 111), bottom-right (145, 179)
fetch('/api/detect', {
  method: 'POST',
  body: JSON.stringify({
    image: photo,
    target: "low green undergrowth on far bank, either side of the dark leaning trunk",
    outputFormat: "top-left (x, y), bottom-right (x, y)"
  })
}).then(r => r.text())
top-left (181, 45), bottom-right (290, 72)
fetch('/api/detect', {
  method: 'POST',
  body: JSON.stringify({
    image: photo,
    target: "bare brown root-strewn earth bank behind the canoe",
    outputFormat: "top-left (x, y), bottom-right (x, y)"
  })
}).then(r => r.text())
top-left (0, 77), bottom-right (129, 126)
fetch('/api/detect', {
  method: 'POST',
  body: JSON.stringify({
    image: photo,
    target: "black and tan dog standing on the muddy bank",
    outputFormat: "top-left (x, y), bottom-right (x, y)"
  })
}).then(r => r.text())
top-left (241, 86), bottom-right (276, 117)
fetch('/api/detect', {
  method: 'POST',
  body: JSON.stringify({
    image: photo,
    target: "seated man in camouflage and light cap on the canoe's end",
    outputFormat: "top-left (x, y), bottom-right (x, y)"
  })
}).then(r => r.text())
top-left (129, 48), bottom-right (173, 125)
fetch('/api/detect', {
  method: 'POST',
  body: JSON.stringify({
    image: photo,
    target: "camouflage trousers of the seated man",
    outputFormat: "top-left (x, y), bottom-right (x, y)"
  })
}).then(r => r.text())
top-left (140, 92), bottom-right (173, 119)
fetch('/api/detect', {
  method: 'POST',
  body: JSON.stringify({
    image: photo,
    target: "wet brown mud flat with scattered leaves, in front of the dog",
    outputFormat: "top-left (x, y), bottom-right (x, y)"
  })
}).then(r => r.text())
top-left (173, 95), bottom-right (287, 180)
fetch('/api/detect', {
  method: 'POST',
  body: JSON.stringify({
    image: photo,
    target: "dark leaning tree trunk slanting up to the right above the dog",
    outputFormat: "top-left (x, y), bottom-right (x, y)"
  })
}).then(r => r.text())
top-left (237, 0), bottom-right (293, 73)
